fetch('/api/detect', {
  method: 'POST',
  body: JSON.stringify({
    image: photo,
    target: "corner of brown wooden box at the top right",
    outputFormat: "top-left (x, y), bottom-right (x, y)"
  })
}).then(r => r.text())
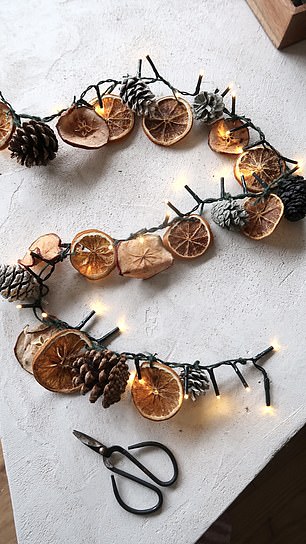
top-left (247, 0), bottom-right (306, 49)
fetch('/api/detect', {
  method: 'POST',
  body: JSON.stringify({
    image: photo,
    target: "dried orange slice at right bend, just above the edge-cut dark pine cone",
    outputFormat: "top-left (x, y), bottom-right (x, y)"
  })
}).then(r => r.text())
top-left (234, 147), bottom-right (285, 193)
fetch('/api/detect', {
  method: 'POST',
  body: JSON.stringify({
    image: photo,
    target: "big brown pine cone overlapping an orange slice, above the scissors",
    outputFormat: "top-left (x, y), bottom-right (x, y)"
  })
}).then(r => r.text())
top-left (72, 349), bottom-right (129, 408)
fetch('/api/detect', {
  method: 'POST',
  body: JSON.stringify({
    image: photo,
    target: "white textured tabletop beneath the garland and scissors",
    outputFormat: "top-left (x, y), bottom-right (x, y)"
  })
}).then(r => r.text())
top-left (0, 0), bottom-right (306, 544)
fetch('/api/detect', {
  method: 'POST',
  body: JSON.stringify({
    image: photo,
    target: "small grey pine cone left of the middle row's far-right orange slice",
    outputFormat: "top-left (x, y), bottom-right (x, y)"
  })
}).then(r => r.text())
top-left (211, 198), bottom-right (249, 230)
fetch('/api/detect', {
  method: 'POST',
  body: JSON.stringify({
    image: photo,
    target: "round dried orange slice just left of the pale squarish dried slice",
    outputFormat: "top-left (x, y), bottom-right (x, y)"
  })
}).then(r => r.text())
top-left (70, 229), bottom-right (116, 280)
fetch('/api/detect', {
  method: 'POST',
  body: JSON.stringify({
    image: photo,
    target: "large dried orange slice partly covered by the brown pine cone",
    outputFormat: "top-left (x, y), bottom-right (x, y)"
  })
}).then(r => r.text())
top-left (33, 329), bottom-right (92, 393)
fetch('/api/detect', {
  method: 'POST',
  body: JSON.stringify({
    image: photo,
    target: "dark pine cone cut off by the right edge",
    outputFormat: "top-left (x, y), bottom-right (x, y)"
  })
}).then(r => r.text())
top-left (275, 176), bottom-right (306, 221)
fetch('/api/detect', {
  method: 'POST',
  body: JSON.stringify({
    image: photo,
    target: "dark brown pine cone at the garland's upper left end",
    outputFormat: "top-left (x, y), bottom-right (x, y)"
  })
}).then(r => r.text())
top-left (9, 120), bottom-right (58, 168)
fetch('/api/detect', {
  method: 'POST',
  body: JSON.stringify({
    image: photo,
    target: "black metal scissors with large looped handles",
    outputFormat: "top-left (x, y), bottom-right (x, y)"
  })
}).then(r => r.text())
top-left (73, 431), bottom-right (178, 514)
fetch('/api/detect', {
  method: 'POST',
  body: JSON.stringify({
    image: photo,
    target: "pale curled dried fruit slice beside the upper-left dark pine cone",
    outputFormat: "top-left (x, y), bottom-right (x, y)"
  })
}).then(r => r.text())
top-left (56, 106), bottom-right (109, 149)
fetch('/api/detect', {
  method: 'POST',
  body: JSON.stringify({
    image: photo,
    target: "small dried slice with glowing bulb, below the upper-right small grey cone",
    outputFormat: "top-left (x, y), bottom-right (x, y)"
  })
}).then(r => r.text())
top-left (208, 119), bottom-right (249, 155)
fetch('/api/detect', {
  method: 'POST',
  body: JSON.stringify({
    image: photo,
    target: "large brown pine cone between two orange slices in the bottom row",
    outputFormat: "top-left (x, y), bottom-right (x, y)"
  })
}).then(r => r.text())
top-left (72, 349), bottom-right (130, 408)
